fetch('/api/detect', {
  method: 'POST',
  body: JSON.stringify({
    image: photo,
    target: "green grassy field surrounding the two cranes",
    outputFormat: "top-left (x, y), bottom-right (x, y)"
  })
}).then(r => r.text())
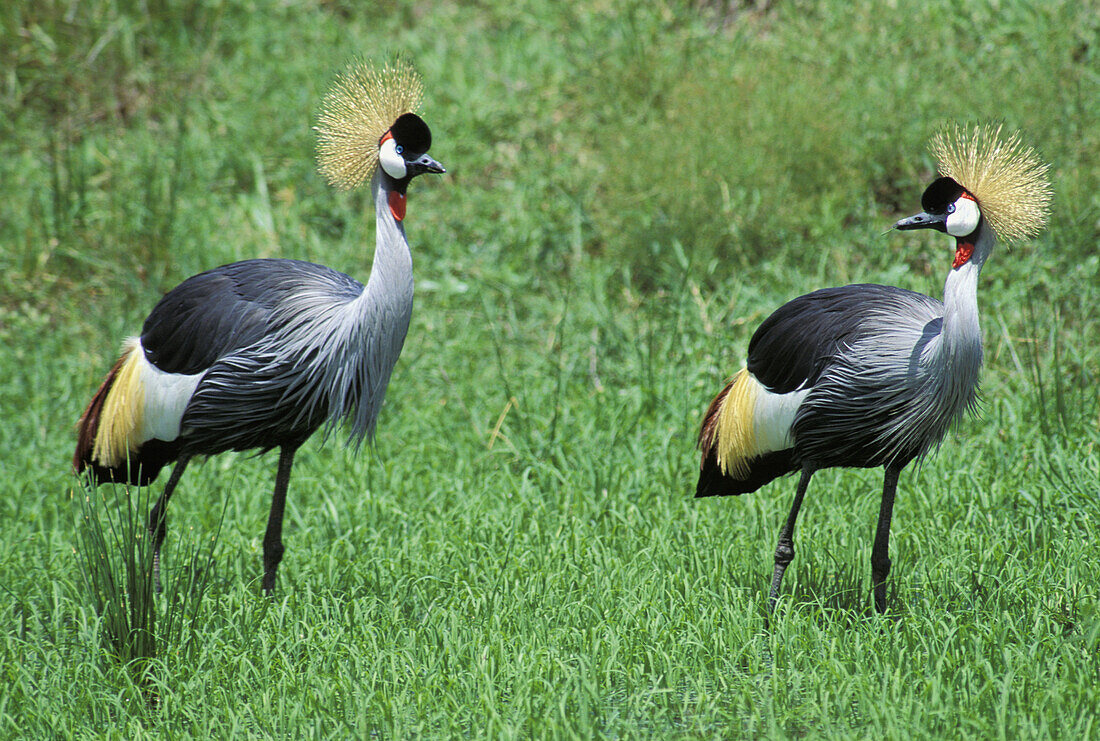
top-left (0, 0), bottom-right (1100, 739)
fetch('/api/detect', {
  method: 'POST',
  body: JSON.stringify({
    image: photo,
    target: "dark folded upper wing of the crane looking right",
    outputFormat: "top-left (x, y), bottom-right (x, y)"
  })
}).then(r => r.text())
top-left (141, 259), bottom-right (363, 375)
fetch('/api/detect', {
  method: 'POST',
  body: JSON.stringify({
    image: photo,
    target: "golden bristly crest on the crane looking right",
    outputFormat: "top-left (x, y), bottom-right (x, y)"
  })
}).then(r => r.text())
top-left (314, 59), bottom-right (424, 190)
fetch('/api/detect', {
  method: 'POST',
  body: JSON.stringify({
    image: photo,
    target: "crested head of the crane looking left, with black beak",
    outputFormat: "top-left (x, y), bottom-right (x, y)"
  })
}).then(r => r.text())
top-left (894, 125), bottom-right (1051, 242)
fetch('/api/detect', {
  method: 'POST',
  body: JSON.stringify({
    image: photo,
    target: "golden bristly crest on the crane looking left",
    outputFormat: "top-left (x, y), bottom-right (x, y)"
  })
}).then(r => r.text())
top-left (928, 124), bottom-right (1053, 241)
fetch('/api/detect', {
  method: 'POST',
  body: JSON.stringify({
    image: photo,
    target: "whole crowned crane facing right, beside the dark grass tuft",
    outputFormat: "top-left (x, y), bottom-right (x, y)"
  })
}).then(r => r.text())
top-left (73, 62), bottom-right (446, 593)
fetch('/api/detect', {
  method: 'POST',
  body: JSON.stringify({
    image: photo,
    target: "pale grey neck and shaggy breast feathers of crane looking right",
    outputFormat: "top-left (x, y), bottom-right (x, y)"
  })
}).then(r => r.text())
top-left (188, 175), bottom-right (413, 450)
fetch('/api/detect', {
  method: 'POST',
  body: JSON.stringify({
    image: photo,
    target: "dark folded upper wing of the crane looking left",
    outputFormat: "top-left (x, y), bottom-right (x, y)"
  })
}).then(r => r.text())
top-left (748, 284), bottom-right (927, 394)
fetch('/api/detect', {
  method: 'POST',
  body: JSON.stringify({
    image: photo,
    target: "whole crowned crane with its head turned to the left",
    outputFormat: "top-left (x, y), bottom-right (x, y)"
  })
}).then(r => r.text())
top-left (695, 125), bottom-right (1051, 612)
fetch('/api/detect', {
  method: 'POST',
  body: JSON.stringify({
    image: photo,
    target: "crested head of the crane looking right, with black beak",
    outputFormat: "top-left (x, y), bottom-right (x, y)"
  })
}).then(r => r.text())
top-left (314, 59), bottom-right (447, 193)
